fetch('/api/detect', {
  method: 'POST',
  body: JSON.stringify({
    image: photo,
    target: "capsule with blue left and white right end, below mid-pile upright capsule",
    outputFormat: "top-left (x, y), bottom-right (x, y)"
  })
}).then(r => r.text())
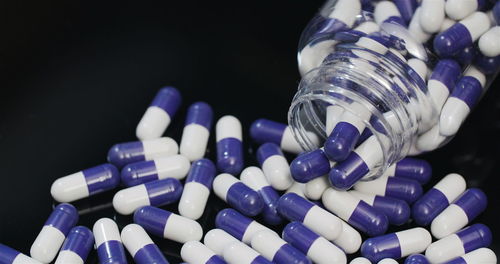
top-left (134, 206), bottom-right (203, 243)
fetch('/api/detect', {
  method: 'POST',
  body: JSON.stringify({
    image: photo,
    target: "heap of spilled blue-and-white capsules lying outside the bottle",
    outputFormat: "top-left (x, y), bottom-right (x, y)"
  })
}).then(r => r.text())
top-left (0, 87), bottom-right (496, 264)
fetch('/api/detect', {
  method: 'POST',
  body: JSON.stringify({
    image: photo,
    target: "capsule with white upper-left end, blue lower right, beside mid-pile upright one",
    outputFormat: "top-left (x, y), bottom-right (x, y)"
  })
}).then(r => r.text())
top-left (213, 173), bottom-right (264, 216)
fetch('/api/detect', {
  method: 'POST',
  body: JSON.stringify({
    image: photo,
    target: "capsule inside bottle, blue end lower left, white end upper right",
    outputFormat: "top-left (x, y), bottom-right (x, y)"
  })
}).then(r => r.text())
top-left (436, 12), bottom-right (490, 57)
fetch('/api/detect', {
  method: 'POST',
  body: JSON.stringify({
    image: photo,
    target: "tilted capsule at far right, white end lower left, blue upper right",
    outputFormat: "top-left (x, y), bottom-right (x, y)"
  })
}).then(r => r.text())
top-left (431, 188), bottom-right (488, 239)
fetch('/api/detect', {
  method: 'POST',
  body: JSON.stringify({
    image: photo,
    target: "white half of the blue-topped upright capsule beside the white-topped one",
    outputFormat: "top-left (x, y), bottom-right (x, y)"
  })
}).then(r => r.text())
top-left (180, 124), bottom-right (210, 161)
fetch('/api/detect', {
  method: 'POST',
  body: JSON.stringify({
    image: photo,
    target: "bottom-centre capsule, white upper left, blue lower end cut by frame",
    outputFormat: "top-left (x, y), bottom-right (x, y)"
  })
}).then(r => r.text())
top-left (251, 230), bottom-right (311, 264)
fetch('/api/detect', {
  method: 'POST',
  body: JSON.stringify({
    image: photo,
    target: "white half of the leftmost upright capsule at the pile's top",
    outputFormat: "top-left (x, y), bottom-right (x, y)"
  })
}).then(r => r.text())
top-left (135, 106), bottom-right (171, 140)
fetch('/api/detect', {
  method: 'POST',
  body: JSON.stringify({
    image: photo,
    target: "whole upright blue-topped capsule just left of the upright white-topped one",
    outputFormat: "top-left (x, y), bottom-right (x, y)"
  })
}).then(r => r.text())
top-left (180, 102), bottom-right (213, 161)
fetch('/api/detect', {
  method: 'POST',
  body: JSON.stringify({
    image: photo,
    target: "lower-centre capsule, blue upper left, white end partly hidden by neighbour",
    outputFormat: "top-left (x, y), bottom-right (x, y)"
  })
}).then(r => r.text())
top-left (215, 208), bottom-right (278, 245)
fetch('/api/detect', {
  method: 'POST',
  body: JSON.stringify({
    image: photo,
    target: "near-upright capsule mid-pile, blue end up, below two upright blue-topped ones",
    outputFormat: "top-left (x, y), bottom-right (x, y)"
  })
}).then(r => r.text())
top-left (179, 159), bottom-right (216, 220)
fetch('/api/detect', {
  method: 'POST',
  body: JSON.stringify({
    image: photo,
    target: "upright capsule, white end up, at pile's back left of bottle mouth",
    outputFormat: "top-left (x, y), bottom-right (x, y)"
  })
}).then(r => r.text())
top-left (215, 115), bottom-right (244, 175)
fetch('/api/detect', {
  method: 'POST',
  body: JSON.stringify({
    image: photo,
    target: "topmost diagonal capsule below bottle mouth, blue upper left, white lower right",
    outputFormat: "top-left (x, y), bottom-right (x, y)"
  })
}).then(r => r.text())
top-left (278, 193), bottom-right (342, 240)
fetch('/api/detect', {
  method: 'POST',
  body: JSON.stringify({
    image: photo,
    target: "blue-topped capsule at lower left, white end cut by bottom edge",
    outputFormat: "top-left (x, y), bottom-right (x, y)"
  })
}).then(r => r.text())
top-left (55, 226), bottom-right (94, 264)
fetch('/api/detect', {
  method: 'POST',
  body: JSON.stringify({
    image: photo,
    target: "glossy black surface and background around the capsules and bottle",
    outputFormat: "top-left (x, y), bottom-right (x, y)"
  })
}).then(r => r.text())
top-left (0, 1), bottom-right (500, 263)
